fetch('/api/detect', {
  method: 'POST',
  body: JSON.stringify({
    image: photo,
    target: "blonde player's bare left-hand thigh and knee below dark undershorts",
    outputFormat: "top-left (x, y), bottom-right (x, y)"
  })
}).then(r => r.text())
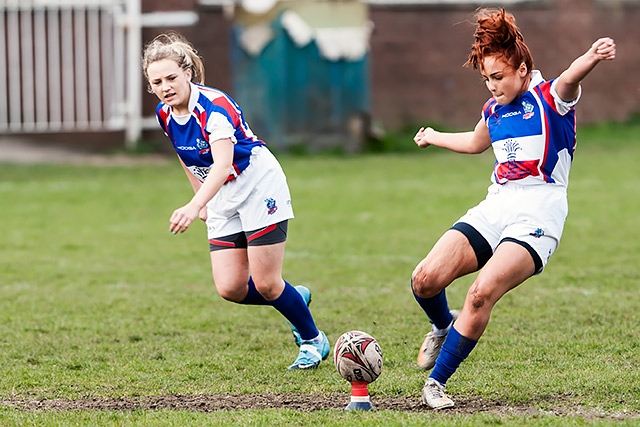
top-left (210, 248), bottom-right (249, 301)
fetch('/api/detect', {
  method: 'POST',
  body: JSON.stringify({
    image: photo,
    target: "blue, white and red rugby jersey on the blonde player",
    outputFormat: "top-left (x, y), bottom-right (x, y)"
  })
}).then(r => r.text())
top-left (156, 83), bottom-right (265, 182)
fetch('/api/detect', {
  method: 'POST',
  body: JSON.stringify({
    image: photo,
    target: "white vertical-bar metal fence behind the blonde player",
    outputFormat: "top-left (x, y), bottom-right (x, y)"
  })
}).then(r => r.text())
top-left (0, 0), bottom-right (142, 144)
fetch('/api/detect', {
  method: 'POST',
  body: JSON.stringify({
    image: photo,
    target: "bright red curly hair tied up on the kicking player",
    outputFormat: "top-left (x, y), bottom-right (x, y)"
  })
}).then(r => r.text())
top-left (464, 8), bottom-right (533, 72)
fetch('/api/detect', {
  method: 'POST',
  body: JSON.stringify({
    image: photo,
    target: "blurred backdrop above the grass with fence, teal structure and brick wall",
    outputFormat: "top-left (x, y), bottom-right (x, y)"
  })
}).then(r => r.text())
top-left (0, 0), bottom-right (640, 152)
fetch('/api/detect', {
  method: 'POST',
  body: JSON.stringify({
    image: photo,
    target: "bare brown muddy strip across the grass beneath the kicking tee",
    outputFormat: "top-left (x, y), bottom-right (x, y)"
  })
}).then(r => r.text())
top-left (0, 394), bottom-right (640, 420)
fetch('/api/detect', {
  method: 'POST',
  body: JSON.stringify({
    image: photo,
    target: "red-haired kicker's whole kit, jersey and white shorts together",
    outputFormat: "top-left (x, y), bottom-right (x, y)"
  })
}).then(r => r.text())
top-left (458, 70), bottom-right (580, 274)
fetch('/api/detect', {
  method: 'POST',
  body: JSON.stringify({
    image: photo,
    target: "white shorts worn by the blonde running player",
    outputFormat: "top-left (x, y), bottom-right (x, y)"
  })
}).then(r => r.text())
top-left (207, 146), bottom-right (294, 239)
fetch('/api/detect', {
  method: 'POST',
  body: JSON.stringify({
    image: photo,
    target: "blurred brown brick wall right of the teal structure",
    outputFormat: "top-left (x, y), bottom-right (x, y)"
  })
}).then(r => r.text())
top-left (370, 0), bottom-right (640, 129)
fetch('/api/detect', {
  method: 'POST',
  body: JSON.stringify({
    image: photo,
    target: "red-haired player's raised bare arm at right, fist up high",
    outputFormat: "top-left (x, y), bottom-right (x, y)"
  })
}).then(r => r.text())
top-left (555, 37), bottom-right (616, 102)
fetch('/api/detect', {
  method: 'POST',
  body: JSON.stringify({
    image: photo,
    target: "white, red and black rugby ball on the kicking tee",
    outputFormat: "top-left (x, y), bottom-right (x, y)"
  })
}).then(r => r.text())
top-left (333, 331), bottom-right (382, 383)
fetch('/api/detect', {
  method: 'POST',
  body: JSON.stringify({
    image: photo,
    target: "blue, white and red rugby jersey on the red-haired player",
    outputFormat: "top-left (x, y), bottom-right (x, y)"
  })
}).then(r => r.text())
top-left (482, 70), bottom-right (580, 188)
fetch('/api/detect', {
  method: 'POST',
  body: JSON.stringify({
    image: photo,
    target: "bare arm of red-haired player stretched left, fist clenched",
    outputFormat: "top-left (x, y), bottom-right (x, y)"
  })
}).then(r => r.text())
top-left (413, 119), bottom-right (491, 154)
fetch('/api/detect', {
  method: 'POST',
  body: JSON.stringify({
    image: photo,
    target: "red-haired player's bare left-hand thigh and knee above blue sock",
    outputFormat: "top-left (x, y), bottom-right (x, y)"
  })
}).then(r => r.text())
top-left (411, 229), bottom-right (478, 297)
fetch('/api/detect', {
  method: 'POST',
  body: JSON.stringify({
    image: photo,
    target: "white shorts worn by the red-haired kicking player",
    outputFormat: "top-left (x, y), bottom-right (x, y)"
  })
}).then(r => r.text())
top-left (458, 182), bottom-right (568, 274)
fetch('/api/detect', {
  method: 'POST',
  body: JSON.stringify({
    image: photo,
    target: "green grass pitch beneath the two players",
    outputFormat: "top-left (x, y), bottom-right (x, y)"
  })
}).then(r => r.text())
top-left (0, 122), bottom-right (640, 426)
